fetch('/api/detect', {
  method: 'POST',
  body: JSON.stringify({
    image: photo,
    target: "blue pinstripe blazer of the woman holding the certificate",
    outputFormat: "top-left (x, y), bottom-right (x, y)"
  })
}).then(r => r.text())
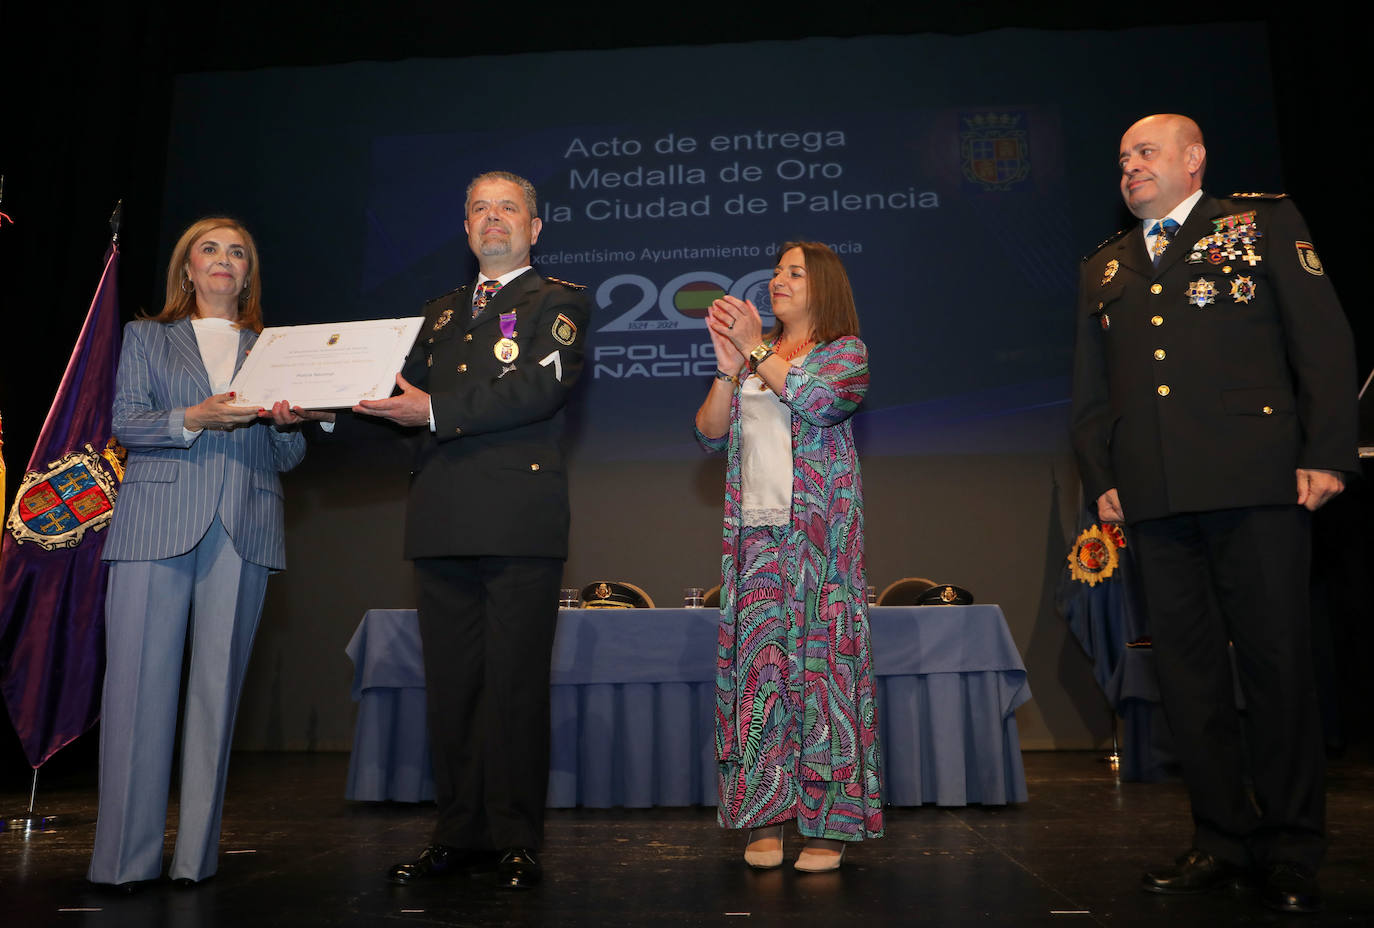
top-left (102, 319), bottom-right (305, 571)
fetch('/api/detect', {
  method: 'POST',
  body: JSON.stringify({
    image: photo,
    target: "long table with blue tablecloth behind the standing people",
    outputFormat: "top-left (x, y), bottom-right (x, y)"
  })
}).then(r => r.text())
top-left (345, 605), bottom-right (1031, 808)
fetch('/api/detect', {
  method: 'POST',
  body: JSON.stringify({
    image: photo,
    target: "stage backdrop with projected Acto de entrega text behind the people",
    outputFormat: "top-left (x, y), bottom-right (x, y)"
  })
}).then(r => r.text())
top-left (150, 25), bottom-right (1281, 749)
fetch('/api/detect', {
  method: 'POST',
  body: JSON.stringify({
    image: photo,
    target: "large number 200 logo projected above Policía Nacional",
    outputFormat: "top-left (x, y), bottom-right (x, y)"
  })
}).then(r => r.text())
top-left (596, 269), bottom-right (772, 331)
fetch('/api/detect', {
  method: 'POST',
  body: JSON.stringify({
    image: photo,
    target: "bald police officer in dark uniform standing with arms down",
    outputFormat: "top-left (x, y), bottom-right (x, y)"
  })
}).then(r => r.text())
top-left (1072, 115), bottom-right (1356, 912)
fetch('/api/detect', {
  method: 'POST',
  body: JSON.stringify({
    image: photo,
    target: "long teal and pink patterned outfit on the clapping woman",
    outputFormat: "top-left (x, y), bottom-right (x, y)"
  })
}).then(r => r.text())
top-left (697, 335), bottom-right (883, 841)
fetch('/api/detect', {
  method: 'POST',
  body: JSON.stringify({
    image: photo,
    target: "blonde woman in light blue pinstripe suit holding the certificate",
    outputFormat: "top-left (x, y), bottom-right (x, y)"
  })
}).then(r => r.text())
top-left (87, 217), bottom-right (305, 890)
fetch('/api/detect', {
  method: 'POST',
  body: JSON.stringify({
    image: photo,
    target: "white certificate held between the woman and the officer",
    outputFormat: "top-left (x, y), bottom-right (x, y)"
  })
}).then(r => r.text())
top-left (229, 316), bottom-right (425, 410)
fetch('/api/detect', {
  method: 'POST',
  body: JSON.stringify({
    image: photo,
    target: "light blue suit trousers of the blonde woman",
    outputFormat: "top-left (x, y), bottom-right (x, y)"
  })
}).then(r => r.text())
top-left (87, 517), bottom-right (268, 884)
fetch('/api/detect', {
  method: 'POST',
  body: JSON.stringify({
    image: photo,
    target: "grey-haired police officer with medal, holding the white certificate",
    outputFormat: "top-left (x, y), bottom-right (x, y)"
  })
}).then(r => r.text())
top-left (353, 172), bottom-right (588, 888)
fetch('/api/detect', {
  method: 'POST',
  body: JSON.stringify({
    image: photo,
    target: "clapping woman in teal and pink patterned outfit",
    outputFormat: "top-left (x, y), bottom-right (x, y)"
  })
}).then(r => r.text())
top-left (697, 242), bottom-right (882, 872)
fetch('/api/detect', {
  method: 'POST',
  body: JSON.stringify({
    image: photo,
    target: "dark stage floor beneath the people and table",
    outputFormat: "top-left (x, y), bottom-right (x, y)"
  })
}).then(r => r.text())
top-left (0, 752), bottom-right (1374, 928)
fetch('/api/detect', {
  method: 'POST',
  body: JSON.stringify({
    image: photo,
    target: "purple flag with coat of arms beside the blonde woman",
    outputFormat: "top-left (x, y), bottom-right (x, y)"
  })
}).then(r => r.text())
top-left (0, 245), bottom-right (124, 767)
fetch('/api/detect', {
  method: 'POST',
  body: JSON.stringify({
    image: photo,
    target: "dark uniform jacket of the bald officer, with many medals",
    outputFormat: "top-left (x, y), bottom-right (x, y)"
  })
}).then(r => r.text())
top-left (1072, 195), bottom-right (1356, 521)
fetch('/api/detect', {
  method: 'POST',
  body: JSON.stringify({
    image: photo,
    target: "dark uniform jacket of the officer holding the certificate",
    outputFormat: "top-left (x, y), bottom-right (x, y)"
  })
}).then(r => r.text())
top-left (403, 268), bottom-right (589, 558)
